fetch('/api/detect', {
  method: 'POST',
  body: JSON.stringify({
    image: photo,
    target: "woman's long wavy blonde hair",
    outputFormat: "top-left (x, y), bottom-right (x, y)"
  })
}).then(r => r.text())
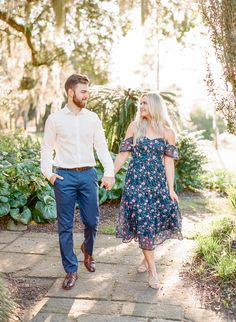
top-left (134, 93), bottom-right (172, 141)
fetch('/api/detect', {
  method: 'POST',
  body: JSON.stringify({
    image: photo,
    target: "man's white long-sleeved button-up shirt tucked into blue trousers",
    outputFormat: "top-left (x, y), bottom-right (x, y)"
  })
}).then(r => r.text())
top-left (41, 106), bottom-right (114, 179)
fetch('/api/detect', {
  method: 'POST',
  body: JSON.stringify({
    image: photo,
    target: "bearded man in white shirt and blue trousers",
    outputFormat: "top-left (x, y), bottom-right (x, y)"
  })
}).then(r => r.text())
top-left (41, 74), bottom-right (115, 290)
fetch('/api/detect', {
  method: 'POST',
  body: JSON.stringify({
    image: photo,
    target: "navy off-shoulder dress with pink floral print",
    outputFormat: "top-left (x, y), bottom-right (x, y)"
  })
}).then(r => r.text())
top-left (116, 137), bottom-right (182, 250)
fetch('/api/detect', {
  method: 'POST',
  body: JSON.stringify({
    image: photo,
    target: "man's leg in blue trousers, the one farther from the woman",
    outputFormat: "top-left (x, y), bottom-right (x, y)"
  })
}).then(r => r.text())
top-left (54, 170), bottom-right (78, 273)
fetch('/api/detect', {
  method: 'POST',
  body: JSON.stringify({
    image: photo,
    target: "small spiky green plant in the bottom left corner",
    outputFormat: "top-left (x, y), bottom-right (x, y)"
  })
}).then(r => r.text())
top-left (0, 276), bottom-right (16, 322)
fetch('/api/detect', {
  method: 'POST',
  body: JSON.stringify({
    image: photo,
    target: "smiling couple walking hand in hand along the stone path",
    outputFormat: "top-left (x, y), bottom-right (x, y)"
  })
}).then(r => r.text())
top-left (41, 74), bottom-right (182, 290)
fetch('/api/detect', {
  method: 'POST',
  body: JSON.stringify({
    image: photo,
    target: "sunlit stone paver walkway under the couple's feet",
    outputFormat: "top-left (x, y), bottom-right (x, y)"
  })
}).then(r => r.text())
top-left (0, 224), bottom-right (234, 322)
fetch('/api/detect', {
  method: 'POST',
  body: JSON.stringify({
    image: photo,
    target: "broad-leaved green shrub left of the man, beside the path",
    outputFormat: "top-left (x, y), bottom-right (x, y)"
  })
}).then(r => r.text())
top-left (0, 132), bottom-right (56, 224)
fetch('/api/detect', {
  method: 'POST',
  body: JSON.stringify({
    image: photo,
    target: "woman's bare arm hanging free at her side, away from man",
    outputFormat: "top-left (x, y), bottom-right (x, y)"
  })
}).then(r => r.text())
top-left (164, 130), bottom-right (178, 201)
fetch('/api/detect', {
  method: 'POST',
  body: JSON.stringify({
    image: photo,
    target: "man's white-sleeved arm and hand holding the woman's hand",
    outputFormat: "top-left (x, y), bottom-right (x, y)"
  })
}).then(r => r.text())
top-left (94, 117), bottom-right (115, 190)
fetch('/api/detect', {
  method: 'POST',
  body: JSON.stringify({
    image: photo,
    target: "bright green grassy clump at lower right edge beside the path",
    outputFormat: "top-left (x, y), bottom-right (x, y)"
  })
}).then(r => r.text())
top-left (192, 217), bottom-right (236, 308)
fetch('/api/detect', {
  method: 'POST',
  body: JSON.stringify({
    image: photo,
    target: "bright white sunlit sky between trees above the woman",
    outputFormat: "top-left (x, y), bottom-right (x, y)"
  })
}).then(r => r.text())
top-left (110, 9), bottom-right (217, 113)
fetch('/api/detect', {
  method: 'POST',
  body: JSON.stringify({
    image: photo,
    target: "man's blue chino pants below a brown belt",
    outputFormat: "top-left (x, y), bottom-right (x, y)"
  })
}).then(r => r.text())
top-left (54, 168), bottom-right (99, 273)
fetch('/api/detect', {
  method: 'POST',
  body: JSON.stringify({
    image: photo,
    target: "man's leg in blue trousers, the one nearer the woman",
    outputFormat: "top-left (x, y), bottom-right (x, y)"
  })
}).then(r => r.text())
top-left (78, 169), bottom-right (99, 271)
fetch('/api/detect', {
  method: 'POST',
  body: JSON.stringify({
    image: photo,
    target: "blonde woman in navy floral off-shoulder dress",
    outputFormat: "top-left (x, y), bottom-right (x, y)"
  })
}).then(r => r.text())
top-left (115, 93), bottom-right (182, 289)
